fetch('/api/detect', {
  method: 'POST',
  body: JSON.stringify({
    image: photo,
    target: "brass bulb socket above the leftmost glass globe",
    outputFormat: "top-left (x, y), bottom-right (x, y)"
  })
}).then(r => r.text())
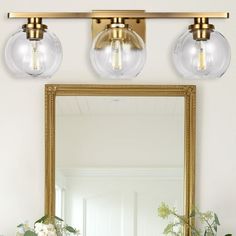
top-left (22, 18), bottom-right (48, 41)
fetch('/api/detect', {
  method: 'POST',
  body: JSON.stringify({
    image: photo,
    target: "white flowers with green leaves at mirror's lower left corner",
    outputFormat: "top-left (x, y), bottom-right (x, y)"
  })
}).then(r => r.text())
top-left (16, 216), bottom-right (79, 236)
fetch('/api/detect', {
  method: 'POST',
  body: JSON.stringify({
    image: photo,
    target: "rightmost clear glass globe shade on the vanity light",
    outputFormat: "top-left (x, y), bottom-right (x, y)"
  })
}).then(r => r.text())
top-left (173, 31), bottom-right (231, 79)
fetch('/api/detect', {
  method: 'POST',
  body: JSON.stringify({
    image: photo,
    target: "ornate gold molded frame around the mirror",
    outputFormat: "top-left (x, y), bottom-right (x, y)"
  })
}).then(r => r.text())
top-left (45, 84), bottom-right (196, 236)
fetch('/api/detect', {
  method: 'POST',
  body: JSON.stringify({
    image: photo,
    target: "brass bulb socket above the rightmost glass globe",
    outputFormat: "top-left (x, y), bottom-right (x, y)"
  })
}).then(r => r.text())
top-left (189, 18), bottom-right (215, 41)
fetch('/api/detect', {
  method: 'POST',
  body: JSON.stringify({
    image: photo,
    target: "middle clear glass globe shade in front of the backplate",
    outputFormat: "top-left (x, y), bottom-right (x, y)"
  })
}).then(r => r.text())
top-left (90, 28), bottom-right (146, 79)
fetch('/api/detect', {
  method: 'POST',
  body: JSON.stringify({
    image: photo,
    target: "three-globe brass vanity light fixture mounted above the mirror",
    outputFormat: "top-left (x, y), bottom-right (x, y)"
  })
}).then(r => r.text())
top-left (5, 10), bottom-right (230, 79)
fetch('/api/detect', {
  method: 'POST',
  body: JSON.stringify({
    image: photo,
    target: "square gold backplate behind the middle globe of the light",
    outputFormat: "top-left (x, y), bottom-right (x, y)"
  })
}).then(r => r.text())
top-left (92, 10), bottom-right (146, 42)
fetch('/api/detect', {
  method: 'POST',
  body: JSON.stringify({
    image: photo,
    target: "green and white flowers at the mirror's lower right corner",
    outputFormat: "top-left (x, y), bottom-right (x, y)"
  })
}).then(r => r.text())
top-left (158, 203), bottom-right (232, 236)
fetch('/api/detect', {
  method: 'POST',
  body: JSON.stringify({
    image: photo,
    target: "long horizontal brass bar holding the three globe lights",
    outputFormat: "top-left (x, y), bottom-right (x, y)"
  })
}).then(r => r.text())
top-left (8, 10), bottom-right (229, 19)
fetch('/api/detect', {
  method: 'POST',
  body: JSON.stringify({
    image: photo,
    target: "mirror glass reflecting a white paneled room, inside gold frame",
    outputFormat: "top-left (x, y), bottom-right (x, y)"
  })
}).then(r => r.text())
top-left (55, 96), bottom-right (185, 236)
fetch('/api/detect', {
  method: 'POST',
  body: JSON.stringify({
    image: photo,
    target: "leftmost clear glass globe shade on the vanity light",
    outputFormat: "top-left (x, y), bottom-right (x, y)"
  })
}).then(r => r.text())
top-left (5, 30), bottom-right (62, 78)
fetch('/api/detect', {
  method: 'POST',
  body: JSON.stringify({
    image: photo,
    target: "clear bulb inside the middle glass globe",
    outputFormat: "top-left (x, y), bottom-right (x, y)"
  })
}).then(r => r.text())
top-left (111, 39), bottom-right (123, 70)
